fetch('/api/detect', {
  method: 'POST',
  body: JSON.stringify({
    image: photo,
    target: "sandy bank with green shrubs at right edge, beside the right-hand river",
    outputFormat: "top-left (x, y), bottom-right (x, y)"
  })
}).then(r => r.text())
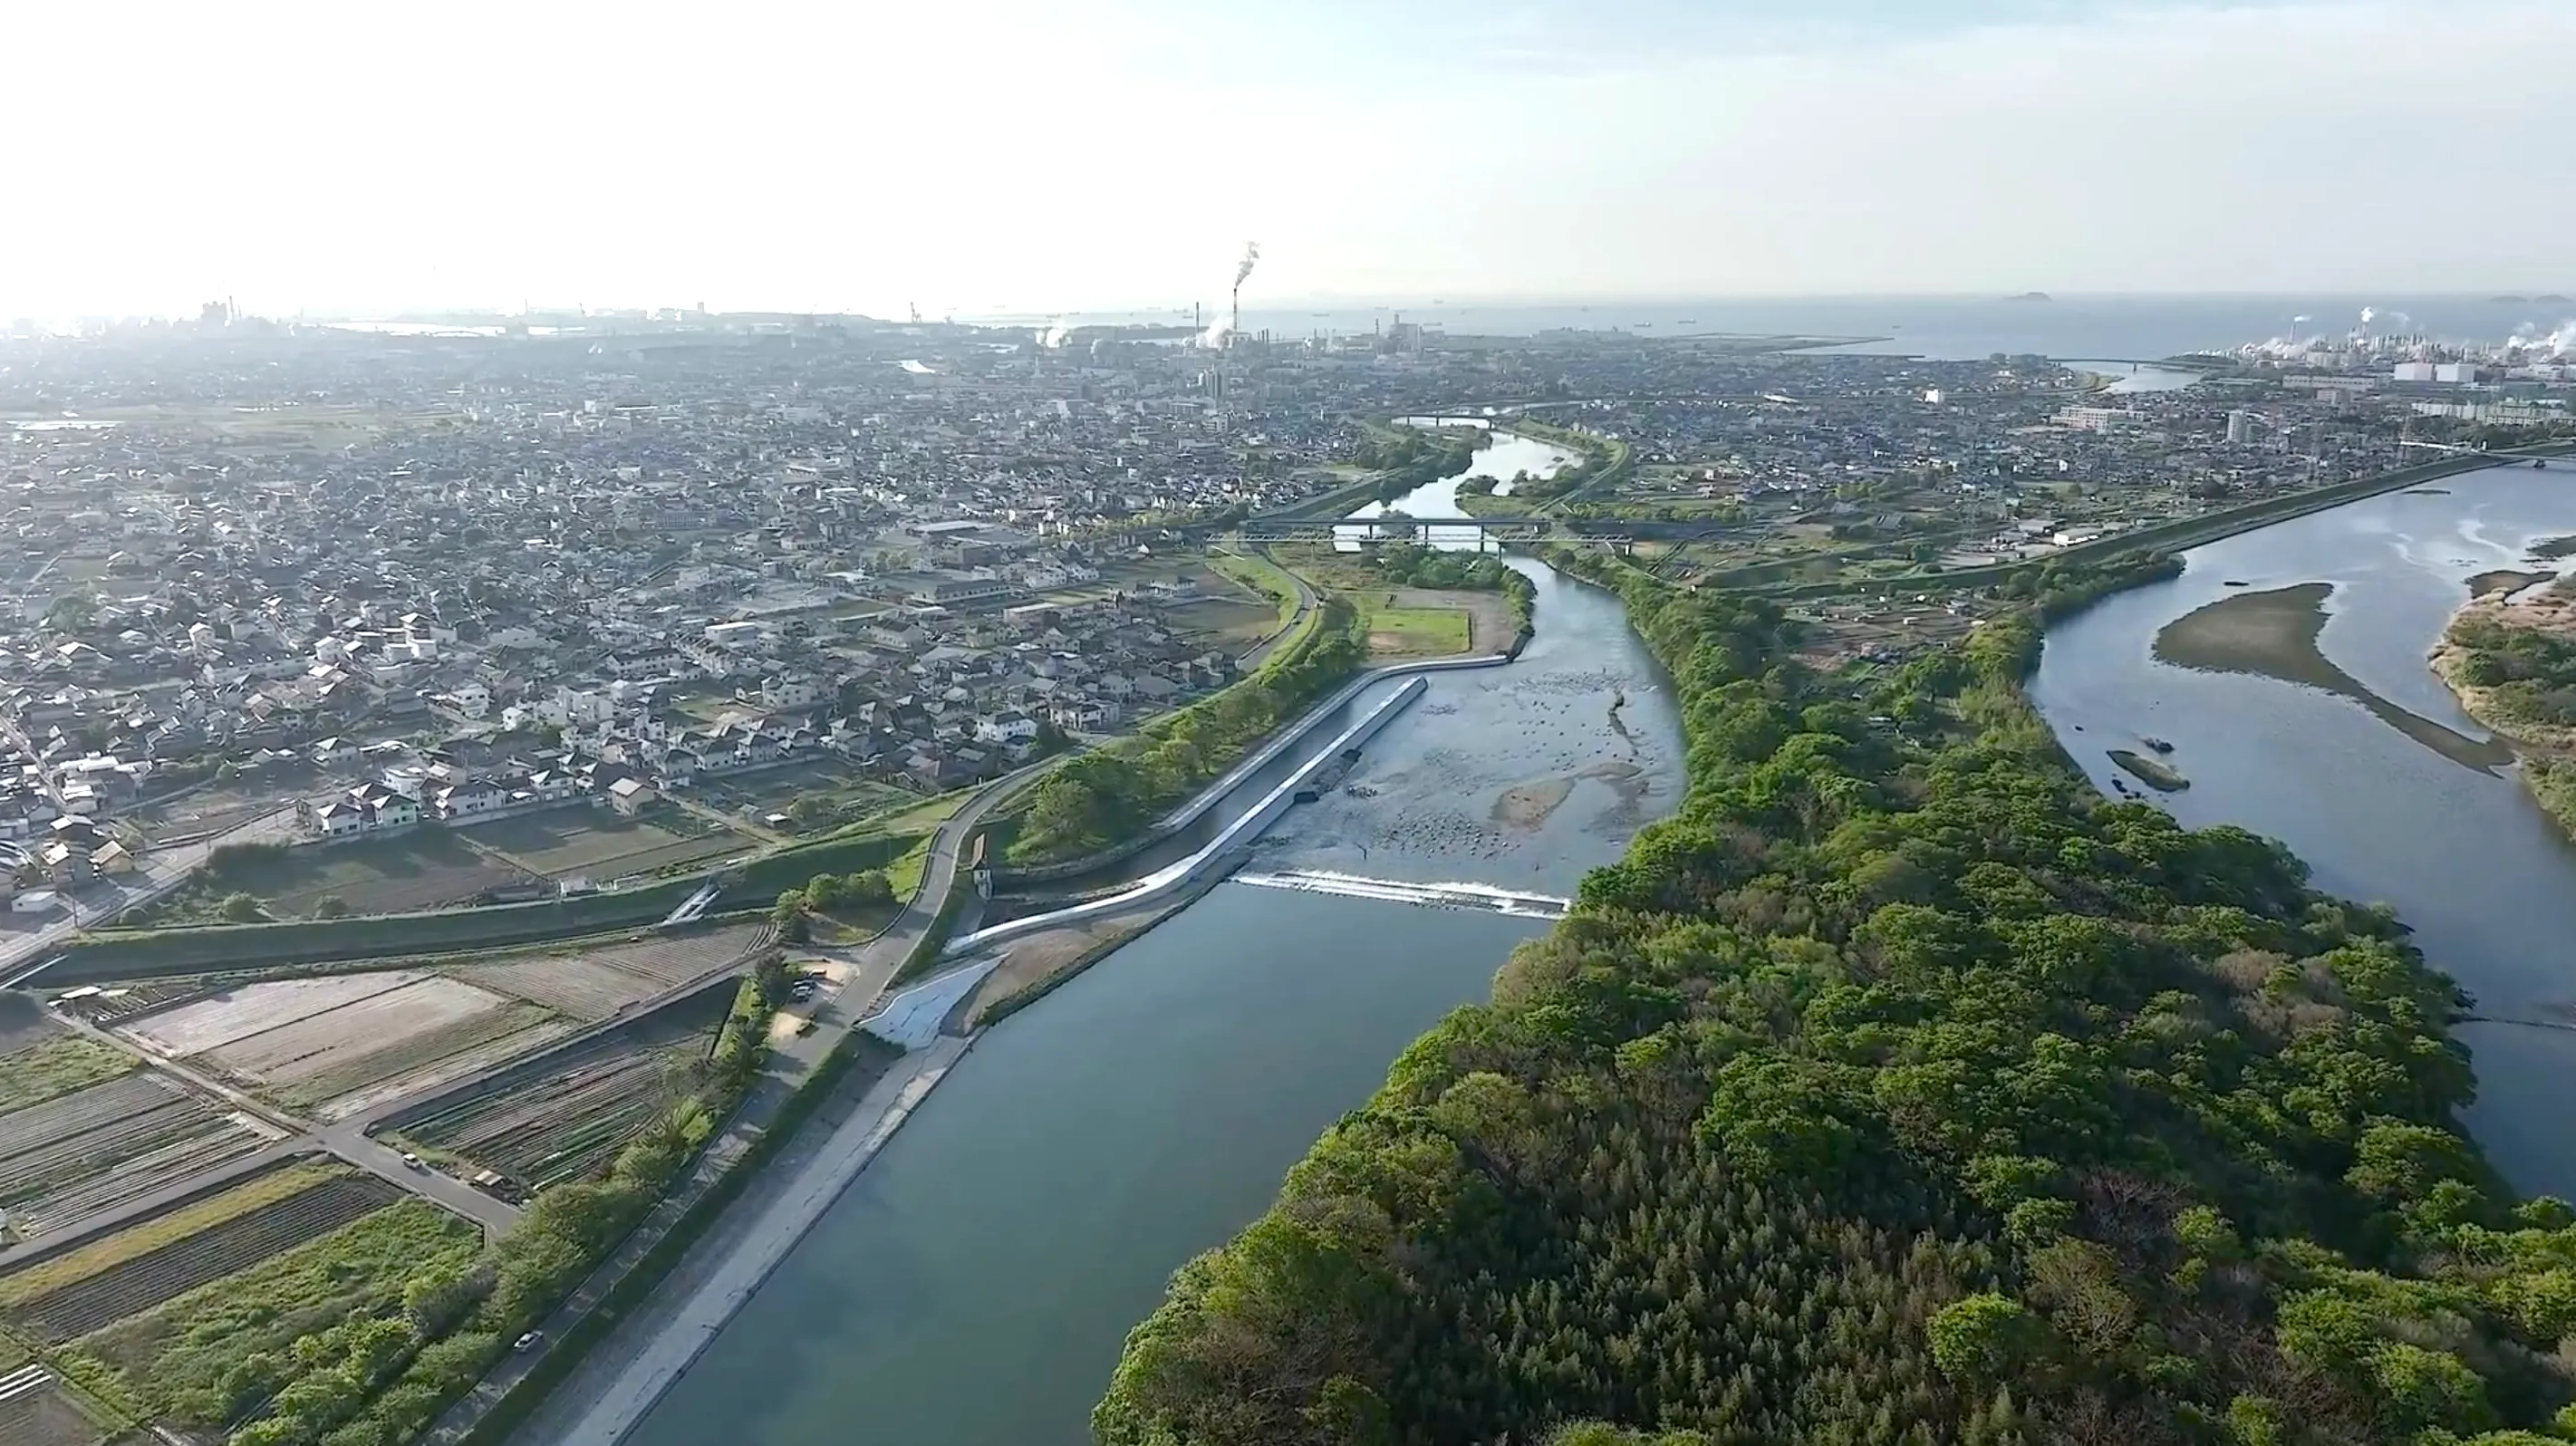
top-left (2432, 569), bottom-right (2576, 835)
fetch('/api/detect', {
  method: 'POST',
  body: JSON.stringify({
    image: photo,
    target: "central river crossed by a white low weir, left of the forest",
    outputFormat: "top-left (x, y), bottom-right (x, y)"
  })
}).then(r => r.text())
top-left (629, 439), bottom-right (1682, 1446)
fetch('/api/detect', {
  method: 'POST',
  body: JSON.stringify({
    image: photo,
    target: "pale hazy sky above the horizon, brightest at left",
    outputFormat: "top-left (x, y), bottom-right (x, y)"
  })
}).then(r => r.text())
top-left (0, 0), bottom-right (2576, 320)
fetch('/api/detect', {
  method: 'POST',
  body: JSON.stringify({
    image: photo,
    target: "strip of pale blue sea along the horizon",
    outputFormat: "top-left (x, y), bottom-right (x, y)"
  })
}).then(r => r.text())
top-left (974, 294), bottom-right (2576, 361)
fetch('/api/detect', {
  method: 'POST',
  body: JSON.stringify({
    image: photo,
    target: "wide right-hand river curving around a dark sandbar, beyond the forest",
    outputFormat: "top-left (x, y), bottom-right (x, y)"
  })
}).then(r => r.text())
top-left (2032, 464), bottom-right (2576, 1199)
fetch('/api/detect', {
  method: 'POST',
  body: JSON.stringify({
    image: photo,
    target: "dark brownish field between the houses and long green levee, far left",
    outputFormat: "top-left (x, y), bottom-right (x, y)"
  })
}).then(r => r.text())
top-left (152, 827), bottom-right (528, 922)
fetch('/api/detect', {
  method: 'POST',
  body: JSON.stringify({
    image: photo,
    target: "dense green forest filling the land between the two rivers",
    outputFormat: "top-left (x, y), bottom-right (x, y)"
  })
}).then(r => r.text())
top-left (1092, 559), bottom-right (2576, 1446)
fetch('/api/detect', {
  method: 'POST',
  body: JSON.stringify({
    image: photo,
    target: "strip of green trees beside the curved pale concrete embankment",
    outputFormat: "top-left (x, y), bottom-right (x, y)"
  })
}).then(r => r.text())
top-left (1009, 598), bottom-right (1368, 863)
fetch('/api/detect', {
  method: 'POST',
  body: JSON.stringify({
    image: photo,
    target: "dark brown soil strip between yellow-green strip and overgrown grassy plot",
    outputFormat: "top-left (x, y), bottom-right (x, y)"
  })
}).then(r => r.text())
top-left (18, 1175), bottom-right (402, 1340)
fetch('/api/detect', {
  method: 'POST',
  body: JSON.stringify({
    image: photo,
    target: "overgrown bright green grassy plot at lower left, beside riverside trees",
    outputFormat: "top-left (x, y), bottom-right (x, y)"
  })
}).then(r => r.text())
top-left (62, 1201), bottom-right (482, 1425)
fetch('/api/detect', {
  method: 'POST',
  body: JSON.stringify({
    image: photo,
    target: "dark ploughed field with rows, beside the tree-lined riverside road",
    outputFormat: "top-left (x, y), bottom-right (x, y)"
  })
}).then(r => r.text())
top-left (400, 989), bottom-right (731, 1191)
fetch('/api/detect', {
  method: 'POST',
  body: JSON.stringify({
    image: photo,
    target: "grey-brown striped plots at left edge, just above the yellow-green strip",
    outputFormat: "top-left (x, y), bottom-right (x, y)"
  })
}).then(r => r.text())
top-left (0, 1070), bottom-right (268, 1238)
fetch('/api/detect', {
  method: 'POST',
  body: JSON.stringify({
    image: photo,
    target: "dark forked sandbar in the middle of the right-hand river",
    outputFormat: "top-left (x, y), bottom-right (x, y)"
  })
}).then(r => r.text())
top-left (2156, 574), bottom-right (2514, 773)
